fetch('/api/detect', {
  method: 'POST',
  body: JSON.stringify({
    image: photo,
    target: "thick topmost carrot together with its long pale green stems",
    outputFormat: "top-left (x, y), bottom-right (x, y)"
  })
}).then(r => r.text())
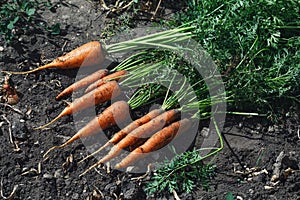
top-left (2, 27), bottom-right (193, 74)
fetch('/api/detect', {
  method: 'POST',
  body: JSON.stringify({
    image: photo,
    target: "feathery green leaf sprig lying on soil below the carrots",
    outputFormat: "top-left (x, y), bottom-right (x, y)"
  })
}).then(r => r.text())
top-left (145, 150), bottom-right (215, 194)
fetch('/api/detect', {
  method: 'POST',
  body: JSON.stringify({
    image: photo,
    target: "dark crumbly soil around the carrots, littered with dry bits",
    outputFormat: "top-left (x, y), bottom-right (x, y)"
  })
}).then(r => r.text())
top-left (0, 0), bottom-right (300, 200)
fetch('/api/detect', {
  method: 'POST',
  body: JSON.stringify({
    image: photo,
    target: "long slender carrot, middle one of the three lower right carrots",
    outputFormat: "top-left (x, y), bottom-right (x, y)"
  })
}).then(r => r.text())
top-left (81, 109), bottom-right (179, 176)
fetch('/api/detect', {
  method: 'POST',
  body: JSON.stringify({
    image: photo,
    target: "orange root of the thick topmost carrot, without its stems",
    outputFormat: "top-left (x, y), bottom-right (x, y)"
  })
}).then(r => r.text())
top-left (2, 41), bottom-right (105, 74)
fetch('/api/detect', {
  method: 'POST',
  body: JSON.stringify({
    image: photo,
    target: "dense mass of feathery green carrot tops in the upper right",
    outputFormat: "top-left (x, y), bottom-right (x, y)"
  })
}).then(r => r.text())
top-left (172, 0), bottom-right (300, 112)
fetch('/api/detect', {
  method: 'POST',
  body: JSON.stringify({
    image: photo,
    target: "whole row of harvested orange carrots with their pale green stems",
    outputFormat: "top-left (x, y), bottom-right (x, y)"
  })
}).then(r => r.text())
top-left (3, 27), bottom-right (220, 174)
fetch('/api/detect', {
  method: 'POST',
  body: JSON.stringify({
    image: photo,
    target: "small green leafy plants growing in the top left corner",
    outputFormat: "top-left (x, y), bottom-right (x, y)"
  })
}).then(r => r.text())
top-left (0, 0), bottom-right (60, 43)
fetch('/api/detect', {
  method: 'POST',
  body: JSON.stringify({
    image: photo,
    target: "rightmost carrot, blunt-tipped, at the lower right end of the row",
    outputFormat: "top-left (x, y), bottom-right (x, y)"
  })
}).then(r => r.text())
top-left (115, 118), bottom-right (190, 169)
